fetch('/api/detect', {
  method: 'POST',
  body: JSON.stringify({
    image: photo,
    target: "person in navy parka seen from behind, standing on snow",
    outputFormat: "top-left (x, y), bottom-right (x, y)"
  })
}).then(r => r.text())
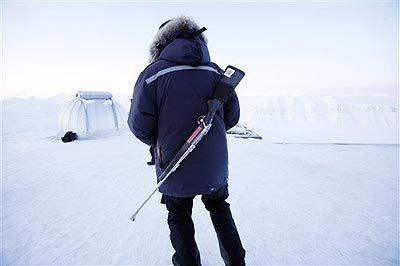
top-left (128, 16), bottom-right (245, 266)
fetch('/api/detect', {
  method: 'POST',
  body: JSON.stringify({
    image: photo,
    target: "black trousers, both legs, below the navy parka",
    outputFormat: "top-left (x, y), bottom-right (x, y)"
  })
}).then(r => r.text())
top-left (162, 185), bottom-right (246, 266)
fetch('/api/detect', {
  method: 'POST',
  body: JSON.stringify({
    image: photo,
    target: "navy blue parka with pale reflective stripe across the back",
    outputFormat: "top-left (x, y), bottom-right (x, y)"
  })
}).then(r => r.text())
top-left (128, 24), bottom-right (240, 197)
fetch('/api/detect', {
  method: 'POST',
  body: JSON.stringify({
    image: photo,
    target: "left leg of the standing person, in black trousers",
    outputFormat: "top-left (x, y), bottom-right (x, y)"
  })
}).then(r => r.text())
top-left (164, 195), bottom-right (201, 266)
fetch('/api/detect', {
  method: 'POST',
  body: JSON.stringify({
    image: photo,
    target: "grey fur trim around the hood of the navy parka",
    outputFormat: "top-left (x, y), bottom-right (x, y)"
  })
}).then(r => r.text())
top-left (149, 16), bottom-right (207, 63)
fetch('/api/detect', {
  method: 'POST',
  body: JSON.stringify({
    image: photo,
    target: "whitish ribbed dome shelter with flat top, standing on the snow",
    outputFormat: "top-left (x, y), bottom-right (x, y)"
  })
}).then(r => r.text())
top-left (58, 91), bottom-right (127, 137)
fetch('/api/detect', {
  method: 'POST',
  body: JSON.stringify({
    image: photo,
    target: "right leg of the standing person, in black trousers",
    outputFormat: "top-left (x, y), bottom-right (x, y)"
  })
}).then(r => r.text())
top-left (201, 185), bottom-right (246, 266)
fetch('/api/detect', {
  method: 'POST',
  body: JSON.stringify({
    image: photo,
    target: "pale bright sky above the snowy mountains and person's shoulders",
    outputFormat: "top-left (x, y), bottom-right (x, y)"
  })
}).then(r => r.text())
top-left (2, 1), bottom-right (399, 98)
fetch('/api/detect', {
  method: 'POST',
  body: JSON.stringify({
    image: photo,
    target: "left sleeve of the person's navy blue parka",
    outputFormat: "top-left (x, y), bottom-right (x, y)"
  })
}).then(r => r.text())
top-left (128, 72), bottom-right (158, 146)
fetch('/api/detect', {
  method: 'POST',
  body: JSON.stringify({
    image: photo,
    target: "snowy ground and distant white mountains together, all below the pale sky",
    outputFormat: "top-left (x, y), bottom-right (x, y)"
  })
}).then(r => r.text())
top-left (1, 95), bottom-right (400, 265)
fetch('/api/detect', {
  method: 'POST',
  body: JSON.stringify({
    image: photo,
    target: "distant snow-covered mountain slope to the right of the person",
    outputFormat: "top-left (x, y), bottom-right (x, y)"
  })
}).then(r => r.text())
top-left (242, 96), bottom-right (399, 128)
